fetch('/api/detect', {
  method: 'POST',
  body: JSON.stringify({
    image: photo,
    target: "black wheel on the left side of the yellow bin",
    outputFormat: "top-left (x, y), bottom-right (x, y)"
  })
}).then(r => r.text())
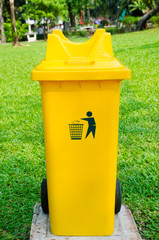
top-left (41, 178), bottom-right (49, 213)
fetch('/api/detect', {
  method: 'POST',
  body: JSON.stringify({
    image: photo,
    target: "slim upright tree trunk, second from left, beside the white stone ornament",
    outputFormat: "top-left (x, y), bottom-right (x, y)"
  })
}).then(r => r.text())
top-left (9, 0), bottom-right (20, 46)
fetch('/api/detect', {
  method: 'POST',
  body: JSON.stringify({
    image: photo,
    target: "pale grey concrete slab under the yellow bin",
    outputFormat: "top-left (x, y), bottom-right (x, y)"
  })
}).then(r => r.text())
top-left (30, 204), bottom-right (142, 240)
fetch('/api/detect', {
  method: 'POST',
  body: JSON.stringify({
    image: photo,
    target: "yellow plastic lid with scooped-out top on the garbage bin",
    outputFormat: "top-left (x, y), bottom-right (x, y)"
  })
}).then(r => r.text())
top-left (31, 29), bottom-right (130, 81)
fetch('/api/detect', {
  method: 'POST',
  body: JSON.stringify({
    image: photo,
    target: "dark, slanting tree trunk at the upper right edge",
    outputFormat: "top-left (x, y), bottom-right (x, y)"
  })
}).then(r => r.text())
top-left (136, 4), bottom-right (159, 31)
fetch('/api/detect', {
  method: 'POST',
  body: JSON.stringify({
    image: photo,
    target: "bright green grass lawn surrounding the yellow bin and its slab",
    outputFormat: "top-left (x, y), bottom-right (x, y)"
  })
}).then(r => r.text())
top-left (0, 29), bottom-right (159, 240)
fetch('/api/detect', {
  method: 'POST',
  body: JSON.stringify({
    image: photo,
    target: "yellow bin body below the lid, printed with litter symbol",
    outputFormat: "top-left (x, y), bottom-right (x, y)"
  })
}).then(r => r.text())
top-left (32, 29), bottom-right (130, 236)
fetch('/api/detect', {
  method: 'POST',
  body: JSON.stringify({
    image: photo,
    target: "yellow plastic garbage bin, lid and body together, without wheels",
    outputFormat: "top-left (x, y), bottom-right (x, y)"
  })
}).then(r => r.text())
top-left (31, 29), bottom-right (130, 236)
